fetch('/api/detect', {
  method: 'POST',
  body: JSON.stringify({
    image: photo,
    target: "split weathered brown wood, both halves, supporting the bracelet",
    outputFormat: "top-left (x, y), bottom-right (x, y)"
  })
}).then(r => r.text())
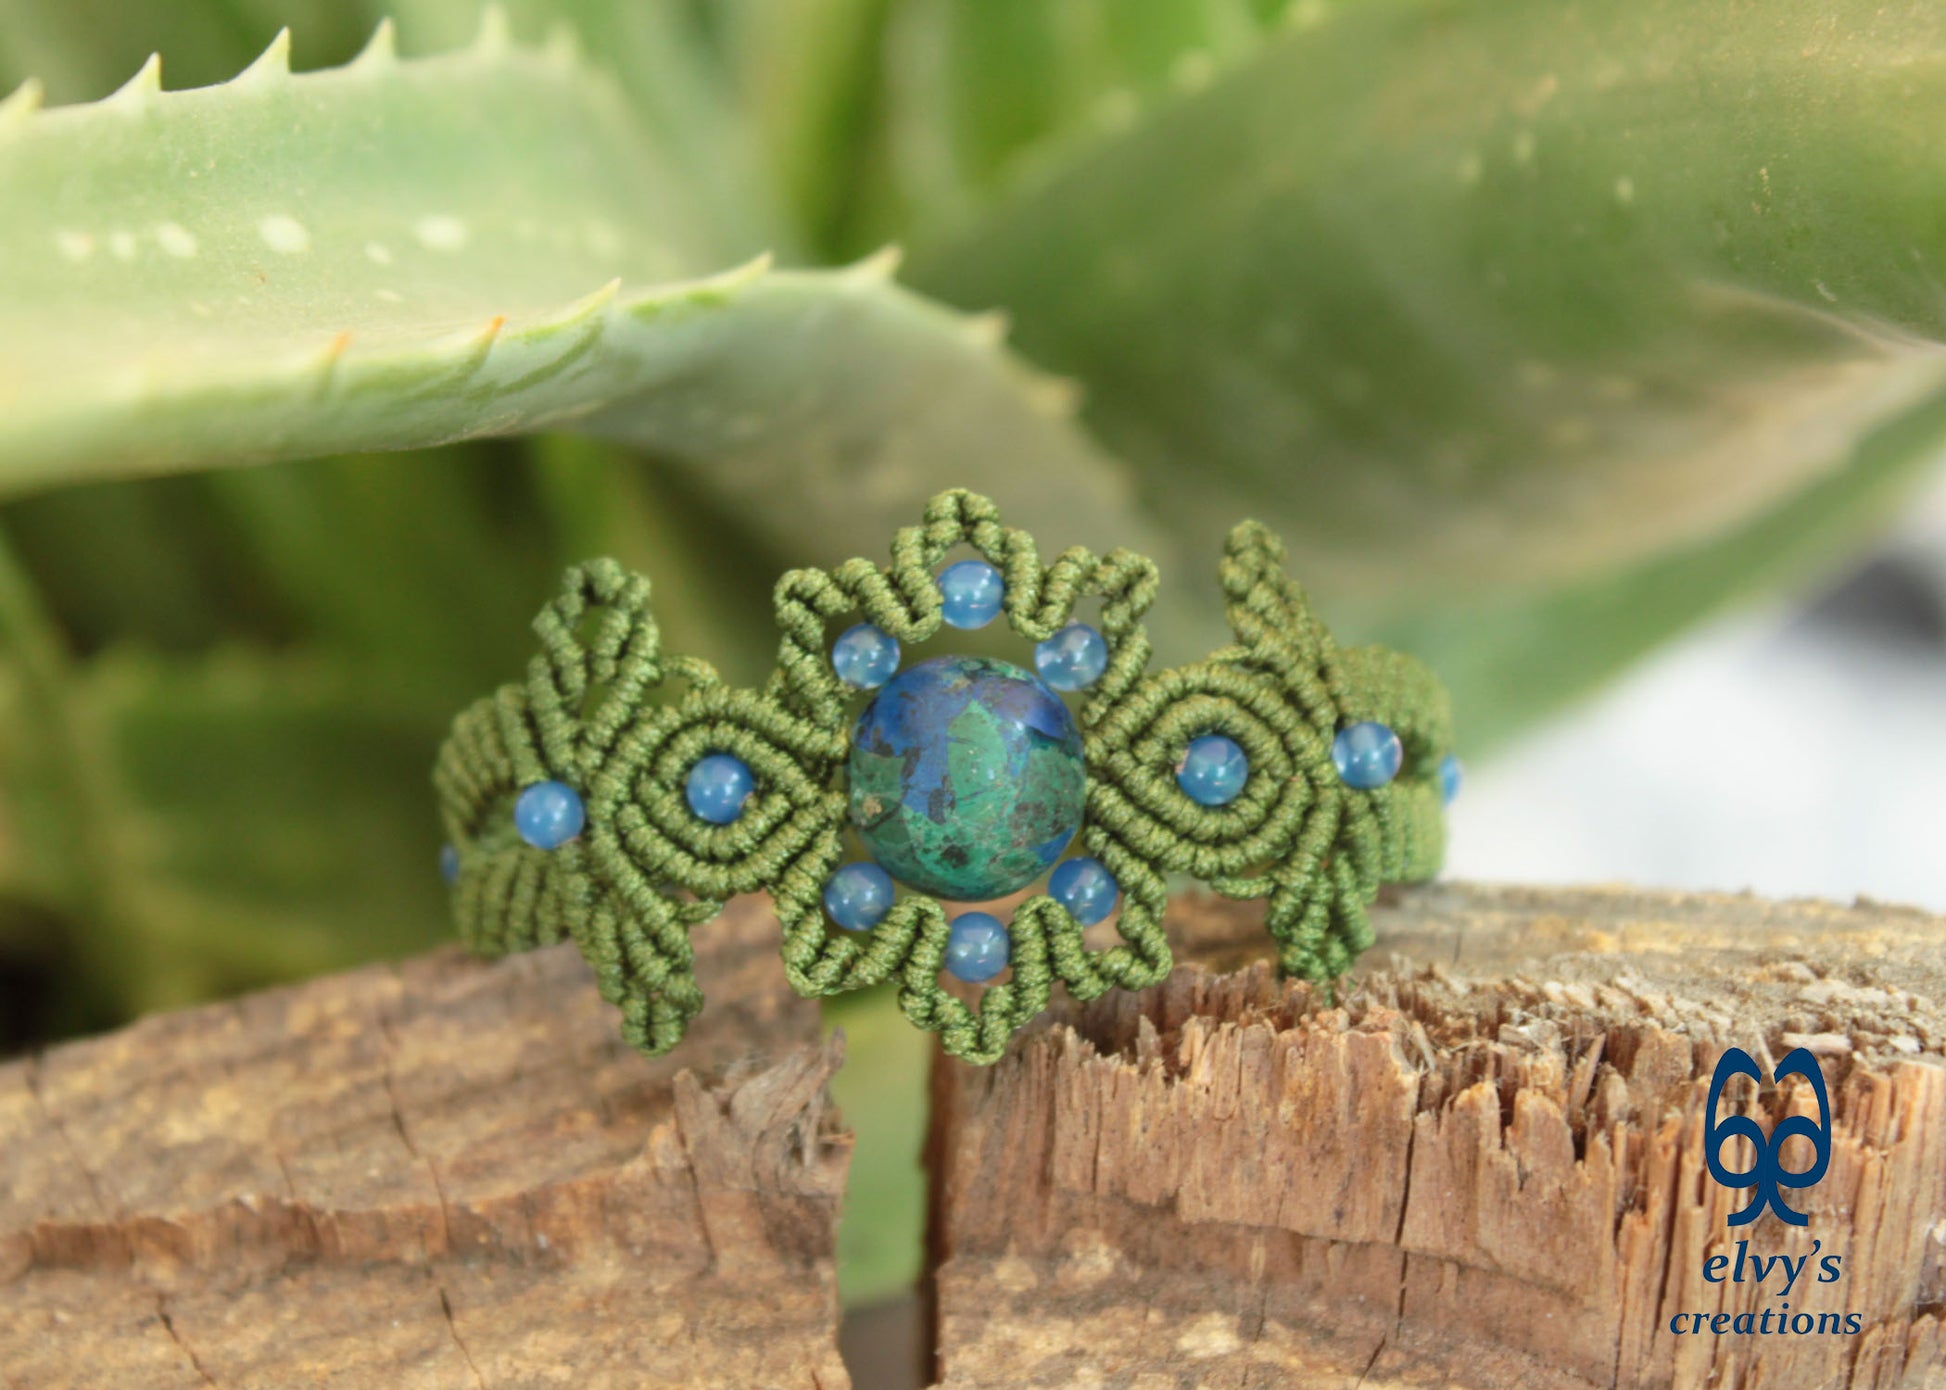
top-left (0, 886), bottom-right (1946, 1390)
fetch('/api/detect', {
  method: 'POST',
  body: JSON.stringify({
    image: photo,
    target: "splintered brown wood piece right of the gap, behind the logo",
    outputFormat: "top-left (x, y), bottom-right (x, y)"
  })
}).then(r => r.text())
top-left (930, 886), bottom-right (1946, 1390)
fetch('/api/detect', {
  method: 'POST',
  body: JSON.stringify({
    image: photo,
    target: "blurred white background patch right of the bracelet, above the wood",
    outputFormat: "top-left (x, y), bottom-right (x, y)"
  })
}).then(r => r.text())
top-left (1446, 479), bottom-right (1946, 911)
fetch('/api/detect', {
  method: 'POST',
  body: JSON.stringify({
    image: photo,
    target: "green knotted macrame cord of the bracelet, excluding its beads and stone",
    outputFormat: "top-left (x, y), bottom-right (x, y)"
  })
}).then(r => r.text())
top-left (434, 491), bottom-right (1454, 1063)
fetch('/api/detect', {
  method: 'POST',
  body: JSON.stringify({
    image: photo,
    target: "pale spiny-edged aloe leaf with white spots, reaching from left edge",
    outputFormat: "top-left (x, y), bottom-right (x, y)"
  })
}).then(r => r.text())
top-left (0, 31), bottom-right (1154, 584)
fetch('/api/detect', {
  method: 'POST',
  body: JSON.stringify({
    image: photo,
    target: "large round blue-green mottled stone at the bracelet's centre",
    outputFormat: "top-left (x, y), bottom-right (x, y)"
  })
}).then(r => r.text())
top-left (847, 656), bottom-right (1088, 903)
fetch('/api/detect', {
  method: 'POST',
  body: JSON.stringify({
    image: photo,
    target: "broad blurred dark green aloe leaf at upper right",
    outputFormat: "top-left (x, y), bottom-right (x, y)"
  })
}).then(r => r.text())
top-left (913, 0), bottom-right (1946, 626)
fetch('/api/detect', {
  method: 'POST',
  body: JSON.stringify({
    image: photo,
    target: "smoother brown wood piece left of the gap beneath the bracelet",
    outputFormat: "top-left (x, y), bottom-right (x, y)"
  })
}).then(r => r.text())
top-left (0, 901), bottom-right (850, 1390)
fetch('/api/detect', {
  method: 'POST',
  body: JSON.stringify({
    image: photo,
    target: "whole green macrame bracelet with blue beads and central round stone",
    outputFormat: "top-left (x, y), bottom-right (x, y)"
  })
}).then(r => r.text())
top-left (434, 491), bottom-right (1458, 1063)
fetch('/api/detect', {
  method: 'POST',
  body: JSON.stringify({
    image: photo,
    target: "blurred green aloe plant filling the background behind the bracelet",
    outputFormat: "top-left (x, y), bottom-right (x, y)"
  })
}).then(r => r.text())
top-left (0, 0), bottom-right (1946, 1297)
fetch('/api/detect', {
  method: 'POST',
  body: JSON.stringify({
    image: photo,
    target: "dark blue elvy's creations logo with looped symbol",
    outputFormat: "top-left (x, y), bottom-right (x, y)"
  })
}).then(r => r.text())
top-left (1670, 1047), bottom-right (1864, 1335)
